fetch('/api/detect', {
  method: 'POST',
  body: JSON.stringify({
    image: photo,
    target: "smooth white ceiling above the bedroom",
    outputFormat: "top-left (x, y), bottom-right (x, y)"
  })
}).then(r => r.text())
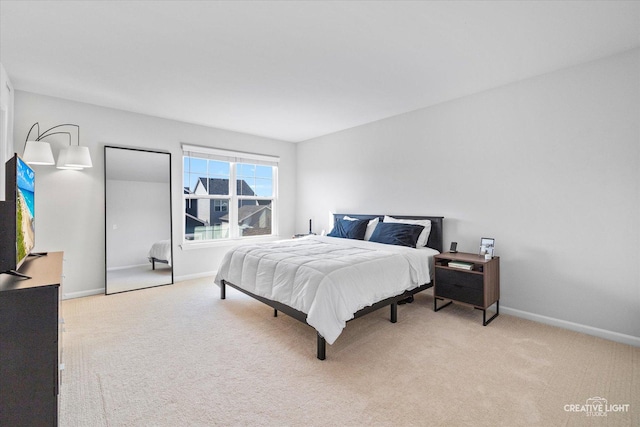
top-left (0, 0), bottom-right (640, 142)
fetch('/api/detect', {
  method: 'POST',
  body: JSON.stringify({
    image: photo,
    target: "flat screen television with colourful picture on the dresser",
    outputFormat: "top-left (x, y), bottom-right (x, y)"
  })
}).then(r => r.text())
top-left (0, 154), bottom-right (36, 275)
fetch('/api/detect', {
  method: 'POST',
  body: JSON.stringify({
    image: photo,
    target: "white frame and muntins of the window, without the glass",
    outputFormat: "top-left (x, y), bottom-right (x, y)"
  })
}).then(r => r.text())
top-left (181, 144), bottom-right (280, 247)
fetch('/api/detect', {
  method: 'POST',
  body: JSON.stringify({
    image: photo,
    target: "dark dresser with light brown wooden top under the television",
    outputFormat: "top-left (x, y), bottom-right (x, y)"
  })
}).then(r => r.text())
top-left (0, 252), bottom-right (62, 427)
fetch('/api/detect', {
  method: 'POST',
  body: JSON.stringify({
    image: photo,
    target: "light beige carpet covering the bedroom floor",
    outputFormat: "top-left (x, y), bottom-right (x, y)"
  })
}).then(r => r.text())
top-left (60, 278), bottom-right (640, 427)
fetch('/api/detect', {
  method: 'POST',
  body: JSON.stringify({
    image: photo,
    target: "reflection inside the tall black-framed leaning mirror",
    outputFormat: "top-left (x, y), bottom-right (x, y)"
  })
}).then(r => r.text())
top-left (104, 146), bottom-right (173, 294)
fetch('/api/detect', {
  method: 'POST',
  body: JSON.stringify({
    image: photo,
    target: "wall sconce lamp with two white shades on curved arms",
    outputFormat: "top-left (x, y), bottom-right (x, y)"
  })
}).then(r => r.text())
top-left (22, 122), bottom-right (93, 170)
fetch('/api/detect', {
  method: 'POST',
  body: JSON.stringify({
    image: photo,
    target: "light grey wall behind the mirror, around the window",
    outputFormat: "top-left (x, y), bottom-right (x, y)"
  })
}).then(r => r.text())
top-left (14, 91), bottom-right (296, 298)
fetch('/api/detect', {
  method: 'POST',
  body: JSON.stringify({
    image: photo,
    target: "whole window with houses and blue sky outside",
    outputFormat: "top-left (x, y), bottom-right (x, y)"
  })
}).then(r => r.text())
top-left (182, 144), bottom-right (279, 243)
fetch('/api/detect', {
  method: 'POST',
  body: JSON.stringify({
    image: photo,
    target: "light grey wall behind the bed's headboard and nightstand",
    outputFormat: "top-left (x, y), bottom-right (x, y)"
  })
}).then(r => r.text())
top-left (296, 49), bottom-right (640, 344)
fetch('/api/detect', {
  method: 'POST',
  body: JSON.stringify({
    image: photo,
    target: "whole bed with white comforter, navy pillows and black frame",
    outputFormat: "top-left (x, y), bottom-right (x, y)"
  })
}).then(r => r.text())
top-left (215, 214), bottom-right (443, 360)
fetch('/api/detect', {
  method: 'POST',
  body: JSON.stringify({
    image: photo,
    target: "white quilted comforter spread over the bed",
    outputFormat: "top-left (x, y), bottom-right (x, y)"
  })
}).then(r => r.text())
top-left (215, 236), bottom-right (438, 344)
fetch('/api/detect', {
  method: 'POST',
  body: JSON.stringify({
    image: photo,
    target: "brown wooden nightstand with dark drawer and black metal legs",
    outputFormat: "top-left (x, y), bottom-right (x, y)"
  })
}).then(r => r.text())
top-left (433, 252), bottom-right (500, 326)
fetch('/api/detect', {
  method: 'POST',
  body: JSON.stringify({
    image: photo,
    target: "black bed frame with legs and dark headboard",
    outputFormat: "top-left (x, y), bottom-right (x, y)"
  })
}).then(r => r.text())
top-left (220, 214), bottom-right (444, 360)
